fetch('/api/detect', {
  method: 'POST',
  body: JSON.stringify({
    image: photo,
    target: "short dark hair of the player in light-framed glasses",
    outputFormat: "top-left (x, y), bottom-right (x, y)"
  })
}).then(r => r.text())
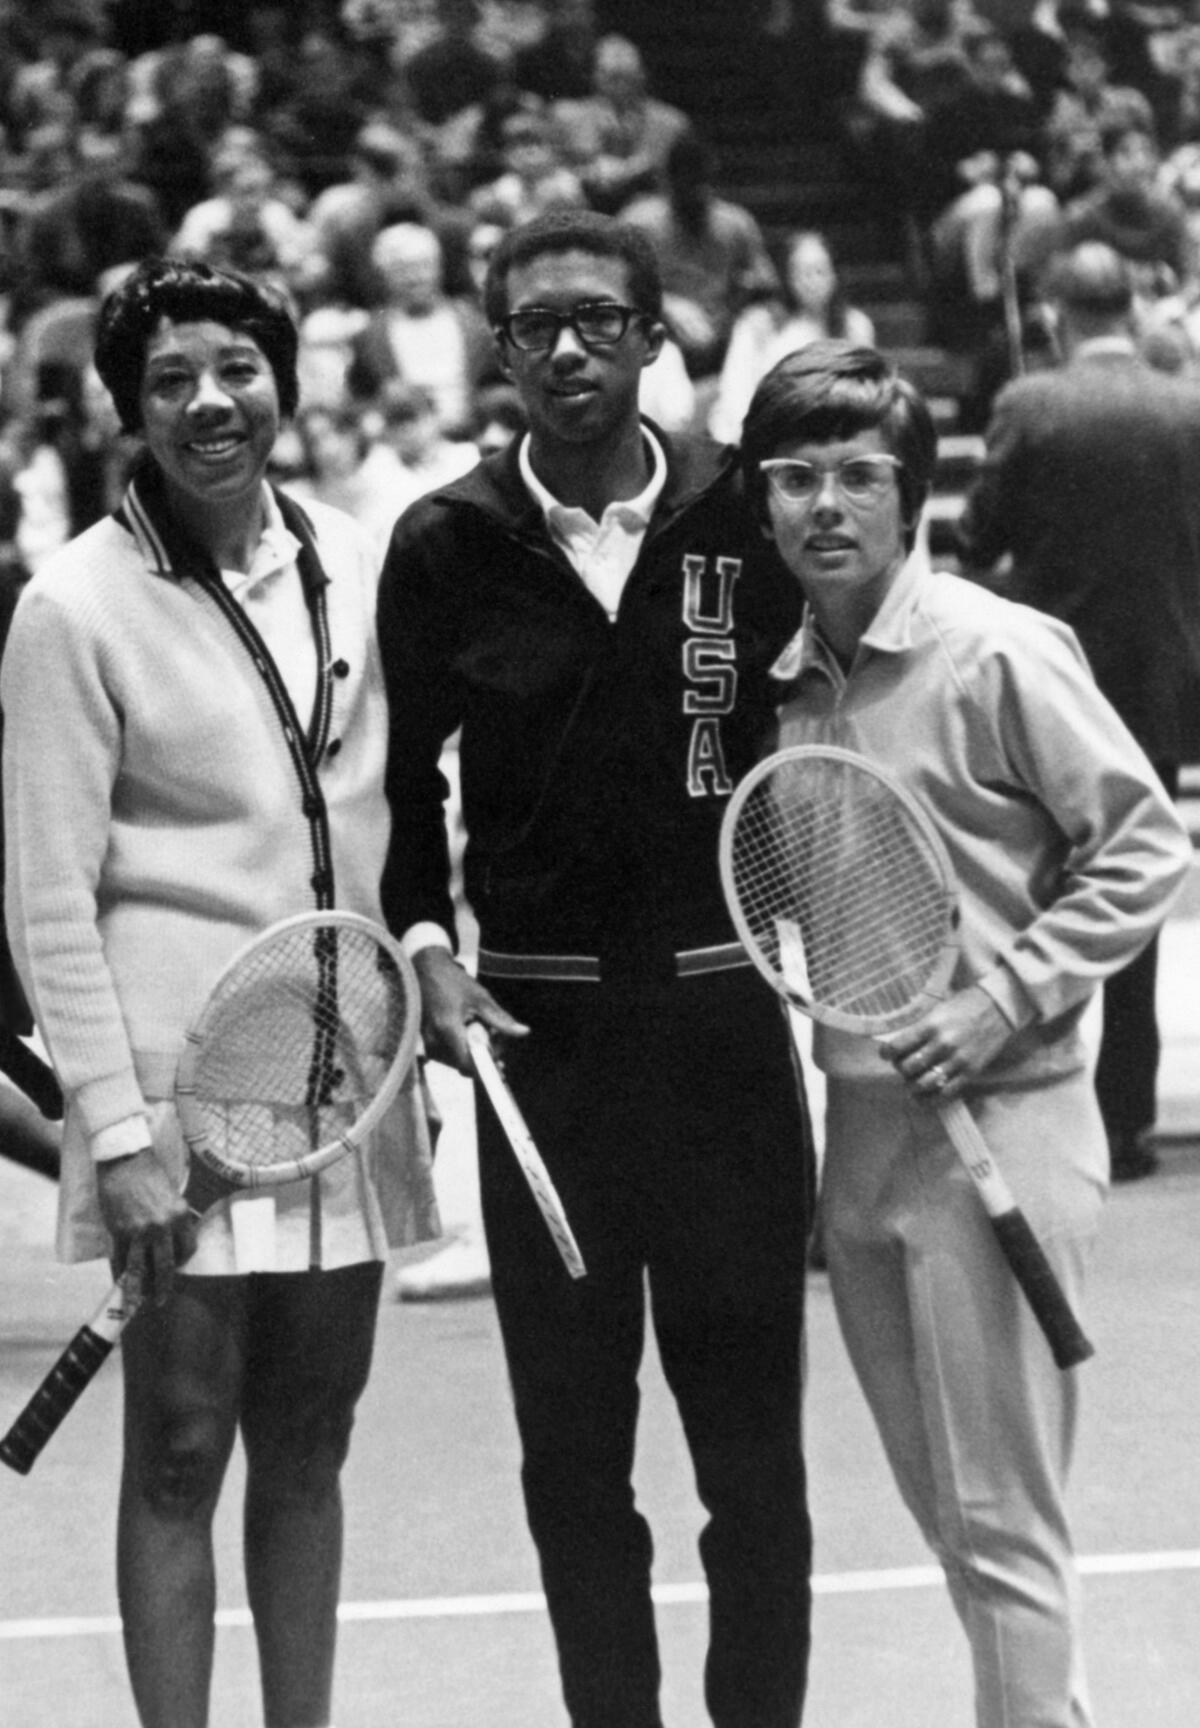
top-left (742, 339), bottom-right (937, 550)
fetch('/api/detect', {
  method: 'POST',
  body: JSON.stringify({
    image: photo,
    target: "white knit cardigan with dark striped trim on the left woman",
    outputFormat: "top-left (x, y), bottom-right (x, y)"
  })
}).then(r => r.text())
top-left (0, 487), bottom-right (434, 1260)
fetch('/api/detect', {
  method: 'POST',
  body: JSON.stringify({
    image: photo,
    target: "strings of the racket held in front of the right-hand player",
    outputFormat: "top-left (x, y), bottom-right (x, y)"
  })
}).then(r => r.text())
top-left (731, 762), bottom-right (948, 1020)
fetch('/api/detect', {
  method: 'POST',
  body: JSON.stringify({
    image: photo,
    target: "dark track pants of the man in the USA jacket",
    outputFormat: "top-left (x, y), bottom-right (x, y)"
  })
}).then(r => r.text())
top-left (477, 969), bottom-right (813, 1728)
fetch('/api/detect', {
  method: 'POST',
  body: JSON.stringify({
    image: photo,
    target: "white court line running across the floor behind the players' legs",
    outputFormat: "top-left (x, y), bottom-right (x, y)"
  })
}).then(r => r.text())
top-left (0, 1548), bottom-right (1200, 1642)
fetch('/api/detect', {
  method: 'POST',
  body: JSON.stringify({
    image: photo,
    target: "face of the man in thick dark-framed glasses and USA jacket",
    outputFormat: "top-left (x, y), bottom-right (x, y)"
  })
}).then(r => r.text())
top-left (501, 252), bottom-right (662, 448)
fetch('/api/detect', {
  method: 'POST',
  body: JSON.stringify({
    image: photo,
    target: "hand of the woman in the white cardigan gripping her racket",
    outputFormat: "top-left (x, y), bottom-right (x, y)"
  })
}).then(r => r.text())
top-left (95, 1146), bottom-right (197, 1306)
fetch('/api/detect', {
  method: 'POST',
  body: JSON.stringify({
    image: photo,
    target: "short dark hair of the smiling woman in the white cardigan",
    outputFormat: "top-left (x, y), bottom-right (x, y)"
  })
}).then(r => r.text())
top-left (95, 257), bottom-right (299, 432)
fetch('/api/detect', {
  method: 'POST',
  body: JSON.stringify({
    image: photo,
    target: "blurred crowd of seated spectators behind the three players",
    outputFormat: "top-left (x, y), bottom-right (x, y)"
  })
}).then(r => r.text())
top-left (0, 0), bottom-right (1200, 586)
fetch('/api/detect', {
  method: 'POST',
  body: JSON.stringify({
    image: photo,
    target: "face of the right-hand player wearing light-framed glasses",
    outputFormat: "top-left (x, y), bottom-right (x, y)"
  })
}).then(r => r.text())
top-left (766, 427), bottom-right (906, 629)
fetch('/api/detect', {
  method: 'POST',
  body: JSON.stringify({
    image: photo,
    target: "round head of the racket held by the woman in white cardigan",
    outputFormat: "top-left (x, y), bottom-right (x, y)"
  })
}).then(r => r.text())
top-left (175, 911), bottom-right (420, 1189)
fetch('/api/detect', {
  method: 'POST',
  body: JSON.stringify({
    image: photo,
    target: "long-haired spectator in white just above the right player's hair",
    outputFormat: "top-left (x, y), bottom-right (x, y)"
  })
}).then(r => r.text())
top-left (709, 228), bottom-right (875, 444)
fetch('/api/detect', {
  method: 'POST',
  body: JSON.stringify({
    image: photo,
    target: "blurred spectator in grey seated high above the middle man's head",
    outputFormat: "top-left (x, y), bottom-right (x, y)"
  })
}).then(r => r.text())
top-left (555, 35), bottom-right (690, 214)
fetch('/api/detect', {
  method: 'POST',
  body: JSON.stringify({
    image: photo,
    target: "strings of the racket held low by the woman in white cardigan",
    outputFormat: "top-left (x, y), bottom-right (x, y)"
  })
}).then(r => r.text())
top-left (194, 926), bottom-right (413, 1170)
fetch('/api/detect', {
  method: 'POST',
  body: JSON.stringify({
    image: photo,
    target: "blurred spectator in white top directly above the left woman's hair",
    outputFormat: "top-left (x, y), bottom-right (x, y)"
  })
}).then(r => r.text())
top-left (171, 126), bottom-right (313, 280)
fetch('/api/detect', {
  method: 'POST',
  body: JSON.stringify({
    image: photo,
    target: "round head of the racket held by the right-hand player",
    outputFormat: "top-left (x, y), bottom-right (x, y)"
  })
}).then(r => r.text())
top-left (719, 745), bottom-right (958, 1037)
